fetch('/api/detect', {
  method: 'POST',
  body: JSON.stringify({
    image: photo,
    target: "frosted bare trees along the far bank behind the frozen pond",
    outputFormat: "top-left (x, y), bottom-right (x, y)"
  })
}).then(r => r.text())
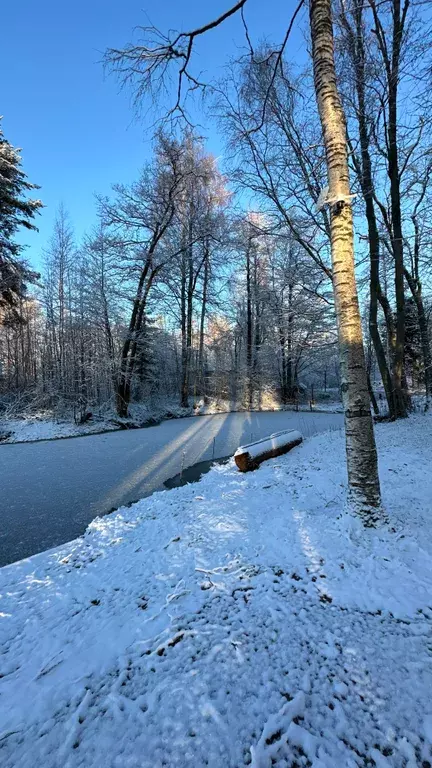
top-left (0, 130), bottom-right (338, 418)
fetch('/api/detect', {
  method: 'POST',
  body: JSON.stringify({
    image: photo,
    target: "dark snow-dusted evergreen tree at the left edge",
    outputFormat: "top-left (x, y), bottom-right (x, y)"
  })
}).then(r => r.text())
top-left (0, 118), bottom-right (42, 321)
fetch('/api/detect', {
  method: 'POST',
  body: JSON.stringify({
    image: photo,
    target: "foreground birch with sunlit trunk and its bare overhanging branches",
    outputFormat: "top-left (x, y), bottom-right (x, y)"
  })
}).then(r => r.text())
top-left (107, 0), bottom-right (381, 525)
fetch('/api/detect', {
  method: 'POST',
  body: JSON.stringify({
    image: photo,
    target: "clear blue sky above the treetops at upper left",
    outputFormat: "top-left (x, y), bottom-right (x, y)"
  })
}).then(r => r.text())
top-left (0, 0), bottom-right (304, 265)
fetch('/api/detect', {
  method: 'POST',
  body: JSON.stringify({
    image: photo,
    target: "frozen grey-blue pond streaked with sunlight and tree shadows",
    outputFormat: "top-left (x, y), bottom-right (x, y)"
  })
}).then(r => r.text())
top-left (0, 412), bottom-right (343, 566)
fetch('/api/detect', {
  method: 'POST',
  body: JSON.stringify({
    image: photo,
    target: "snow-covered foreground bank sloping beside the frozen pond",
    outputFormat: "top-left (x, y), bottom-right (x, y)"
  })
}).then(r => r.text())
top-left (0, 415), bottom-right (432, 768)
